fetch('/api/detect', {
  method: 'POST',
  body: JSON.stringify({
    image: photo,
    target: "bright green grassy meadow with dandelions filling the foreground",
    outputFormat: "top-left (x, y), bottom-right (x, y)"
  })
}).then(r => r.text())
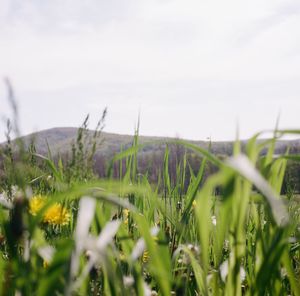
top-left (0, 123), bottom-right (300, 295)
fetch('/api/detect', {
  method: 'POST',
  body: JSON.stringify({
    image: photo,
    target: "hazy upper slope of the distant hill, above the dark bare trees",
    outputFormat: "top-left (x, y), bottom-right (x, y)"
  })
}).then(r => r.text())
top-left (2, 127), bottom-right (300, 158)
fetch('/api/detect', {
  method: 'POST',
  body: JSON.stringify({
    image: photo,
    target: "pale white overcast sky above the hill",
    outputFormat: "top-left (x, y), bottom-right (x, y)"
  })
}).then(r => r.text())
top-left (0, 0), bottom-right (300, 141)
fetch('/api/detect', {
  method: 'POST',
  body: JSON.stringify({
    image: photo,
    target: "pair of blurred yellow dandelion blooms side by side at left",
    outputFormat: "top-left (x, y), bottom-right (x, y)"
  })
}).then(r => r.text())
top-left (29, 195), bottom-right (71, 225)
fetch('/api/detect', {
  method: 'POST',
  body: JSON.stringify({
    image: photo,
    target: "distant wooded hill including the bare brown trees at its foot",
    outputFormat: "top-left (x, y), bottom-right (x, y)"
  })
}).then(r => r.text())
top-left (0, 127), bottom-right (300, 193)
